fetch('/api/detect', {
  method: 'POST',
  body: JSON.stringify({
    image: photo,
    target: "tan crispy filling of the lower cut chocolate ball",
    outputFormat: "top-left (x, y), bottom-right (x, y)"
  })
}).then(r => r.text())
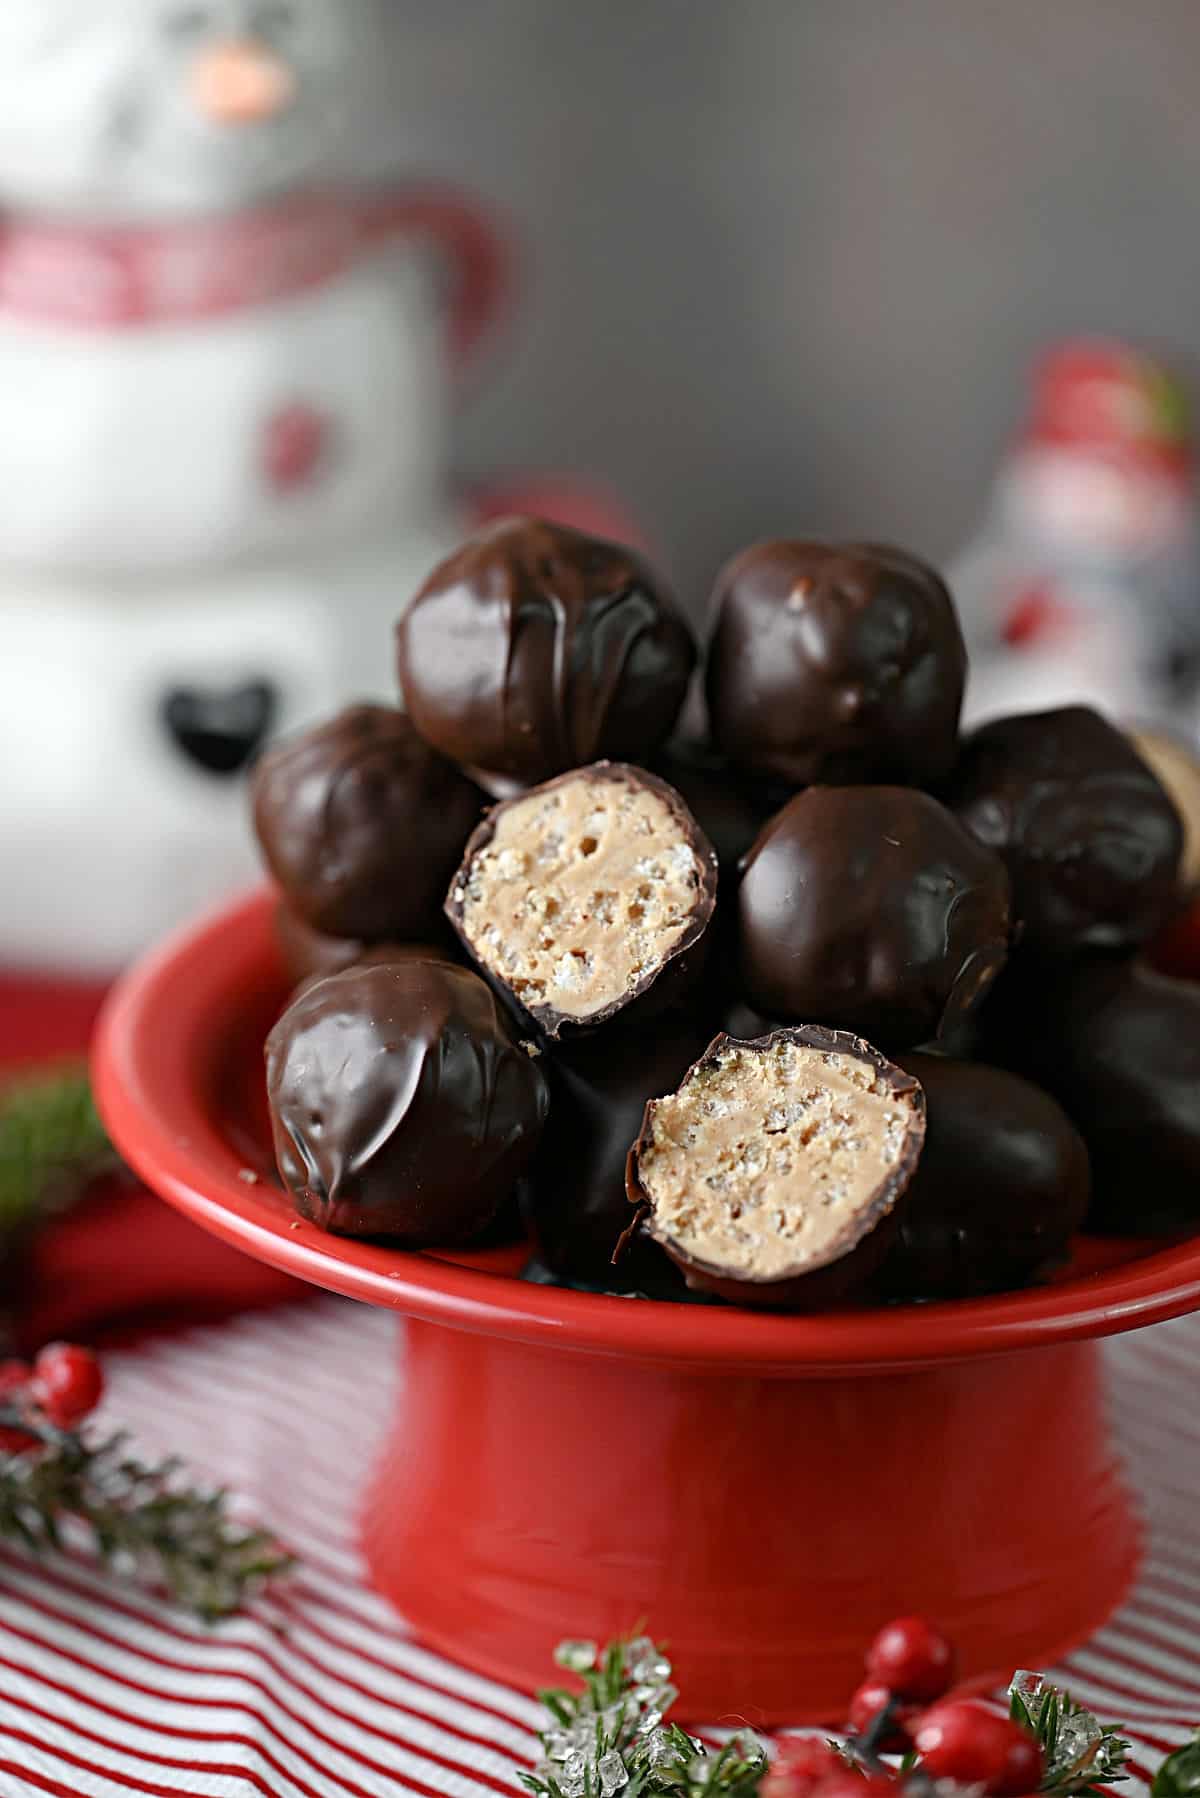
top-left (639, 1041), bottom-right (912, 1280)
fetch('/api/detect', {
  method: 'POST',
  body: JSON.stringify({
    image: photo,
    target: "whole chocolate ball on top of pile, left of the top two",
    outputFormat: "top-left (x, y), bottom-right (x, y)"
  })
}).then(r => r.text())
top-left (398, 518), bottom-right (696, 798)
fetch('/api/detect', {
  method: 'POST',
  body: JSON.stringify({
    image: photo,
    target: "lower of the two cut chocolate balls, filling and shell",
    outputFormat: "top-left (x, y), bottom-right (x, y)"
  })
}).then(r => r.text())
top-left (626, 1027), bottom-right (925, 1309)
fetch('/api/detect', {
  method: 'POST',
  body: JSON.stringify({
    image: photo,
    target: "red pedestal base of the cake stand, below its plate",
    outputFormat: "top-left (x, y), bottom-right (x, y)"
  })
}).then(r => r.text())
top-left (363, 1320), bottom-right (1139, 1726)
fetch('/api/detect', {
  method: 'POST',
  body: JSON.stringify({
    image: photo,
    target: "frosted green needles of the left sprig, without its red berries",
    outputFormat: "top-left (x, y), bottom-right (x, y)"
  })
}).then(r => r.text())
top-left (0, 1406), bottom-right (291, 1622)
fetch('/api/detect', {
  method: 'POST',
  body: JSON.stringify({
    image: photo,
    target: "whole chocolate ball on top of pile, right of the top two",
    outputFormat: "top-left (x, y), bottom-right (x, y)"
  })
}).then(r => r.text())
top-left (707, 541), bottom-right (966, 788)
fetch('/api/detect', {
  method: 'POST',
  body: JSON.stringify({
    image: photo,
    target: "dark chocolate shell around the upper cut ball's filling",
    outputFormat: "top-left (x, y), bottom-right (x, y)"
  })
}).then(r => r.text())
top-left (446, 762), bottom-right (718, 1043)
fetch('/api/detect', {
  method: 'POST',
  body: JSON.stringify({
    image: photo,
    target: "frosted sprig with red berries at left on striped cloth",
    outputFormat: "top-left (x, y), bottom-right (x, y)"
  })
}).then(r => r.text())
top-left (0, 1343), bottom-right (290, 1622)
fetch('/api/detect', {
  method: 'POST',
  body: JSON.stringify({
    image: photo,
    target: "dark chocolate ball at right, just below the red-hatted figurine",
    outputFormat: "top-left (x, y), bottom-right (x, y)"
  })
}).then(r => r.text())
top-left (946, 707), bottom-right (1184, 955)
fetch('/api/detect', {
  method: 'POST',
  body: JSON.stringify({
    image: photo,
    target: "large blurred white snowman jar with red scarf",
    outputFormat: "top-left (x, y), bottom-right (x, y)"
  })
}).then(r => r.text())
top-left (0, 0), bottom-right (502, 971)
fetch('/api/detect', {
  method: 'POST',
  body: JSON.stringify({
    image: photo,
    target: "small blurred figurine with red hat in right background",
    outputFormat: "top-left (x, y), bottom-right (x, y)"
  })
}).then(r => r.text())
top-left (950, 340), bottom-right (1200, 732)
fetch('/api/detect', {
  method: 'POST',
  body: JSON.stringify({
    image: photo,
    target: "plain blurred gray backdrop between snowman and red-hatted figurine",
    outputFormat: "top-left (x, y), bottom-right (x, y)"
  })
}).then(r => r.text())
top-left (380, 0), bottom-right (1200, 608)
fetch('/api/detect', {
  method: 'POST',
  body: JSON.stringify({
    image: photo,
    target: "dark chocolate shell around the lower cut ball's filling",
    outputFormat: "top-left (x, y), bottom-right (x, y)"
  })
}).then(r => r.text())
top-left (626, 1025), bottom-right (925, 1311)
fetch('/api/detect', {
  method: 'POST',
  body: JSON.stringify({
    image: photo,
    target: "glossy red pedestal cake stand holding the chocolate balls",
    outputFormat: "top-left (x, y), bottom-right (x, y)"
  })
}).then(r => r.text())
top-left (95, 895), bottom-right (1200, 1724)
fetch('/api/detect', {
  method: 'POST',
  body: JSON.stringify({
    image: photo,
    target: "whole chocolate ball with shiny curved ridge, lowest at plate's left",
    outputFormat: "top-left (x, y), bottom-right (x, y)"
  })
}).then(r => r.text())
top-left (266, 960), bottom-right (549, 1248)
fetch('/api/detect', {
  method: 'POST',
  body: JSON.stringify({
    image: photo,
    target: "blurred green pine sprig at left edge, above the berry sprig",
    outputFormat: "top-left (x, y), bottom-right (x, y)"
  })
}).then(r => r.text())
top-left (0, 1063), bottom-right (117, 1237)
